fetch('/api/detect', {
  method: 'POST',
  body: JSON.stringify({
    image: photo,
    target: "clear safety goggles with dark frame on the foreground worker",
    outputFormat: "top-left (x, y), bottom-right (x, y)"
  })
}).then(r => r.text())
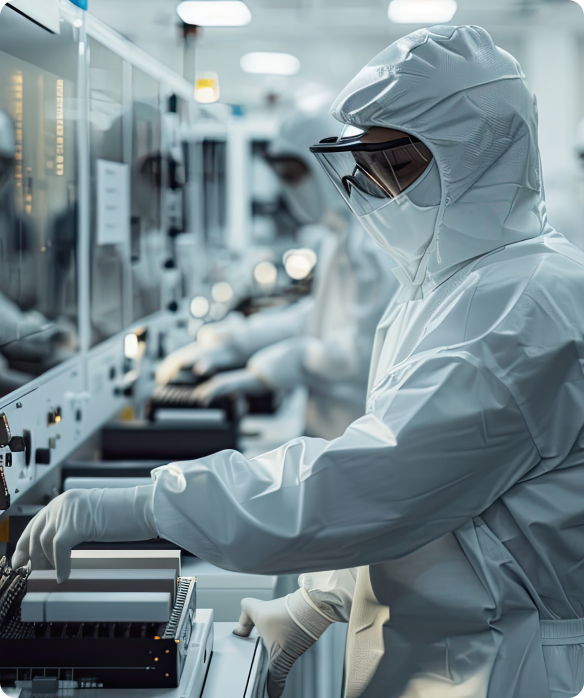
top-left (310, 128), bottom-right (433, 215)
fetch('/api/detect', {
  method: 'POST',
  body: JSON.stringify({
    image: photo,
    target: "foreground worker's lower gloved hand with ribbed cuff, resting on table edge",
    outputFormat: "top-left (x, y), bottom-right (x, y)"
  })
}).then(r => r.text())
top-left (233, 589), bottom-right (334, 698)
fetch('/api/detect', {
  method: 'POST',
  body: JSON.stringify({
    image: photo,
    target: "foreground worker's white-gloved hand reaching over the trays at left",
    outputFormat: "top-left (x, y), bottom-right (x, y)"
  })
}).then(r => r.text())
top-left (12, 485), bottom-right (158, 584)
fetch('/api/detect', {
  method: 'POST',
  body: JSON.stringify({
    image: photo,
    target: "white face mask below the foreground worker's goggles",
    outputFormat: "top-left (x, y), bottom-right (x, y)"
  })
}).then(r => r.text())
top-left (359, 161), bottom-right (441, 283)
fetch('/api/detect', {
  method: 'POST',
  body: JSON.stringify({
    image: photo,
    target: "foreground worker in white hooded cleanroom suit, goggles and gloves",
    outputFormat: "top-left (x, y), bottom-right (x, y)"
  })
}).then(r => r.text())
top-left (14, 26), bottom-right (584, 698)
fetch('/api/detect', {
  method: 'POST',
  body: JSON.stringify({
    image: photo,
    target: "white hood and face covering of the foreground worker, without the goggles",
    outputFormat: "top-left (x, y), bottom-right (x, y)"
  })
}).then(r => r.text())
top-left (324, 26), bottom-right (547, 298)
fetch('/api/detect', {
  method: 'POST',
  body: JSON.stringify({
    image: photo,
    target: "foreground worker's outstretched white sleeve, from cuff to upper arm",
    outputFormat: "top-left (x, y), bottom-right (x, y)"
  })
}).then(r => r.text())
top-left (154, 352), bottom-right (540, 574)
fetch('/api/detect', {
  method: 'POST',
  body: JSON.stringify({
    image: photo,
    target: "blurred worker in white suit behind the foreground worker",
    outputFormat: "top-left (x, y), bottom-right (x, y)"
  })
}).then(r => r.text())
top-left (157, 101), bottom-right (399, 439)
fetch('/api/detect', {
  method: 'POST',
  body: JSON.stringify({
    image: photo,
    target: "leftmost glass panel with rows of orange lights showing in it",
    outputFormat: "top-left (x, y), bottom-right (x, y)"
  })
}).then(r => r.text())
top-left (0, 6), bottom-right (78, 394)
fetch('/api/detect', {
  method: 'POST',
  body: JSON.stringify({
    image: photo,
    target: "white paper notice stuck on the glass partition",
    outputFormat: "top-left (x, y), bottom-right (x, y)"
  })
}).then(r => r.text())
top-left (97, 160), bottom-right (130, 245)
